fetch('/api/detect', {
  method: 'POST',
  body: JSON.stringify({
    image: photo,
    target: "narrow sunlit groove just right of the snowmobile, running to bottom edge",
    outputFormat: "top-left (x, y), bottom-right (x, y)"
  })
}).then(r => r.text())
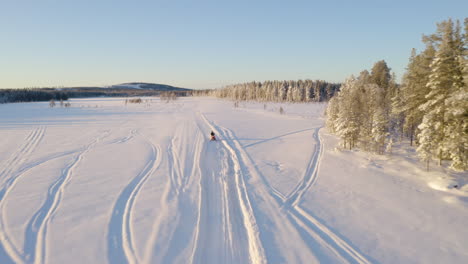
top-left (200, 114), bottom-right (266, 263)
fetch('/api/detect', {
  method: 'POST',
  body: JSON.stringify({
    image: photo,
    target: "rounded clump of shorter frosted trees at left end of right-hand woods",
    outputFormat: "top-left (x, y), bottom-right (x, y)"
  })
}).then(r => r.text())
top-left (327, 65), bottom-right (390, 154)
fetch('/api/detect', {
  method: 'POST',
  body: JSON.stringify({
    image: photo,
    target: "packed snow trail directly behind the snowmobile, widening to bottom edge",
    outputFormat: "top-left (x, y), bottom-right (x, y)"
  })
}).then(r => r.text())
top-left (192, 114), bottom-right (263, 263)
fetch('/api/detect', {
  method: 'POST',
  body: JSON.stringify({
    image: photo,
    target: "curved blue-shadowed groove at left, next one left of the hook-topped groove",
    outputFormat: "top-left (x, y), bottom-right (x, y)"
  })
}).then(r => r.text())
top-left (23, 133), bottom-right (107, 264)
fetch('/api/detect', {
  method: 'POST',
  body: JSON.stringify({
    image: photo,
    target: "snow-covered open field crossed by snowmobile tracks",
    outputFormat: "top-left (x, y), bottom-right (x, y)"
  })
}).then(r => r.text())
top-left (0, 98), bottom-right (468, 263)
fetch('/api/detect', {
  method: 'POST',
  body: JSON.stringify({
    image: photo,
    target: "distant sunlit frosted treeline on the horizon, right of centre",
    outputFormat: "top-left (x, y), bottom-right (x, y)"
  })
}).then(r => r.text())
top-left (211, 80), bottom-right (340, 102)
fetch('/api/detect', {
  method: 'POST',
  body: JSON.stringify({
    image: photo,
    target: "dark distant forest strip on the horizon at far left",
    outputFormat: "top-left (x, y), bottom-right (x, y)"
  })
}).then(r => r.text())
top-left (0, 89), bottom-right (69, 104)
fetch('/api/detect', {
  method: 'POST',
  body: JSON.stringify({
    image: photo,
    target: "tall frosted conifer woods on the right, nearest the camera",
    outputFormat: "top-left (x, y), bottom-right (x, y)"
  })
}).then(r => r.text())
top-left (327, 18), bottom-right (468, 170)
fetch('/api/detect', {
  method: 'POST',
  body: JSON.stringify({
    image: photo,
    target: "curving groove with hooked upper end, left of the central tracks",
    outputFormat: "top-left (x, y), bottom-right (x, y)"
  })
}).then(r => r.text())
top-left (107, 133), bottom-right (161, 264)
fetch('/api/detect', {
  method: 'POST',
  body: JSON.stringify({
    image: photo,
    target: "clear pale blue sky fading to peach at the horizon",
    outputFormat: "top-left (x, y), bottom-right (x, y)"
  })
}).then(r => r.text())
top-left (0, 0), bottom-right (468, 88)
